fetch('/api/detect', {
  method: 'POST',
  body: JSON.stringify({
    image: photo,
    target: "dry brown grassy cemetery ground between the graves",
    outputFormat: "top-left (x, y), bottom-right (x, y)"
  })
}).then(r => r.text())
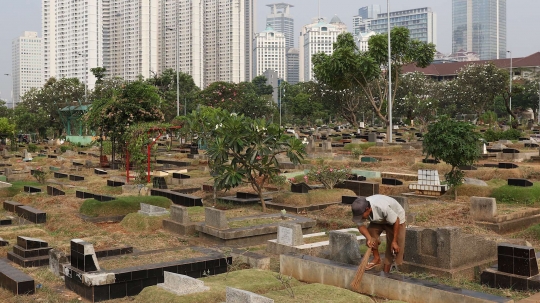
top-left (0, 134), bottom-right (540, 303)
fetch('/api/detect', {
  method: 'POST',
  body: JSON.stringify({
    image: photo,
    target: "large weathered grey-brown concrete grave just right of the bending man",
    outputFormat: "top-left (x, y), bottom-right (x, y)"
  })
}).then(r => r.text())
top-left (400, 227), bottom-right (497, 279)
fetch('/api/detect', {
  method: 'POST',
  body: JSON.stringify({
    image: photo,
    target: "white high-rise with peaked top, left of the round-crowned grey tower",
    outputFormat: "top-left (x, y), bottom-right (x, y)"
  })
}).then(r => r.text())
top-left (253, 24), bottom-right (287, 79)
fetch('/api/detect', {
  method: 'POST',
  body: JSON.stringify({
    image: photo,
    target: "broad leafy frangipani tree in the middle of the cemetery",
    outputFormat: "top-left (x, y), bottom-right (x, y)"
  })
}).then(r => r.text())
top-left (208, 111), bottom-right (305, 212)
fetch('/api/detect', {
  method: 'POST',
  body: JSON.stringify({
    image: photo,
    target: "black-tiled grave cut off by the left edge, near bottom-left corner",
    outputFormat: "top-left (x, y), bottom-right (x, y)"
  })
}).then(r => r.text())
top-left (0, 260), bottom-right (35, 295)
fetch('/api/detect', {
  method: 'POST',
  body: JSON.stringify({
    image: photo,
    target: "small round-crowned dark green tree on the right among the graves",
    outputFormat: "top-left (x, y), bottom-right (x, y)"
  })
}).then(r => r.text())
top-left (423, 116), bottom-right (480, 200)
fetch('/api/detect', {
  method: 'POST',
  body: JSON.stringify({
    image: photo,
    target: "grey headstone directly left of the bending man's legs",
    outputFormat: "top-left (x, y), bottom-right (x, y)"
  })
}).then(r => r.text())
top-left (329, 231), bottom-right (362, 264)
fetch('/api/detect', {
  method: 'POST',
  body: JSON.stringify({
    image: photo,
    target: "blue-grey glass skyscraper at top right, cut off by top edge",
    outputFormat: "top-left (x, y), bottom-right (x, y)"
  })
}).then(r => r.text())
top-left (452, 0), bottom-right (506, 60)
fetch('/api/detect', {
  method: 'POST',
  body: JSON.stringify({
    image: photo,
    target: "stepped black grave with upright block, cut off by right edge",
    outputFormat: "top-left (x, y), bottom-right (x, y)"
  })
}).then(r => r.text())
top-left (480, 243), bottom-right (540, 290)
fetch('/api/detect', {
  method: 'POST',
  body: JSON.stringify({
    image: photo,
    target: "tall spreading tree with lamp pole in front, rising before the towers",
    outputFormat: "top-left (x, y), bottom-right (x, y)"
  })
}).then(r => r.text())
top-left (312, 27), bottom-right (435, 131)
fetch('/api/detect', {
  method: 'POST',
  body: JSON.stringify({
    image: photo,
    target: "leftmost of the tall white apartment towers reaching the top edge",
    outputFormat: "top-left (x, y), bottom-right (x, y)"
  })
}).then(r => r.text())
top-left (42, 0), bottom-right (103, 89)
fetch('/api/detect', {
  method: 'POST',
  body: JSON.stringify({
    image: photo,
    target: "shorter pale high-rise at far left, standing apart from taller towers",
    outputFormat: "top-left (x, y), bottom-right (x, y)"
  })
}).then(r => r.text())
top-left (11, 32), bottom-right (43, 107)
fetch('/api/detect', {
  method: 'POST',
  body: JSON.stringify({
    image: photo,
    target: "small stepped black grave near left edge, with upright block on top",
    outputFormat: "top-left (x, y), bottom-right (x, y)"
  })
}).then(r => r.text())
top-left (7, 236), bottom-right (52, 267)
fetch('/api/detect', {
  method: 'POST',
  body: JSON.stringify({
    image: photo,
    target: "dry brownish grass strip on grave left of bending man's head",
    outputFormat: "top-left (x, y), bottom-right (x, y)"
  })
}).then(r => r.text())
top-left (272, 188), bottom-right (356, 206)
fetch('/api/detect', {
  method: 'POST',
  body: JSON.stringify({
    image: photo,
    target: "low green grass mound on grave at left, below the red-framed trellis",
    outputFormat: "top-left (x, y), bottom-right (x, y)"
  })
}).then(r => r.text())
top-left (79, 196), bottom-right (171, 217)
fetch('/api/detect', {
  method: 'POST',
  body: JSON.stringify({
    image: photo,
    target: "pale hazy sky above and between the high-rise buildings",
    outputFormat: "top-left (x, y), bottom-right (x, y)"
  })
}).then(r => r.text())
top-left (0, 0), bottom-right (540, 100)
